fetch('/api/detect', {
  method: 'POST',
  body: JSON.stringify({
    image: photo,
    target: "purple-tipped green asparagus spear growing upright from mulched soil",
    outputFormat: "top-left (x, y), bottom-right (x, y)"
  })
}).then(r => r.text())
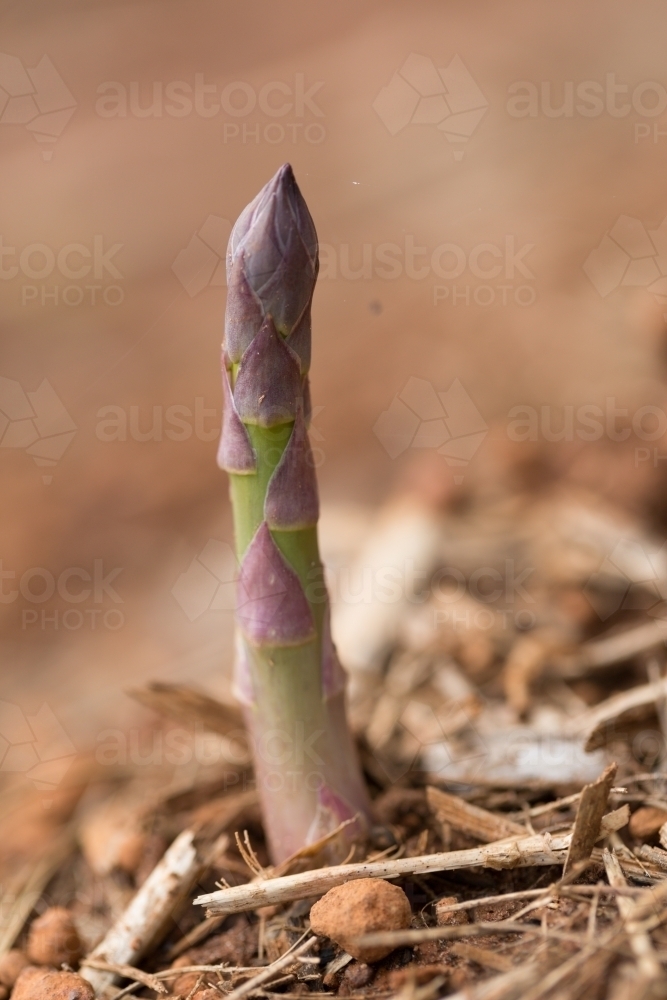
top-left (218, 164), bottom-right (368, 862)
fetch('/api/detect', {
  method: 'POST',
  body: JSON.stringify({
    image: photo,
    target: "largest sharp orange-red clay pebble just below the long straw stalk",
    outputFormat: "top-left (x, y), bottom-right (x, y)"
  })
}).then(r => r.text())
top-left (310, 878), bottom-right (412, 962)
